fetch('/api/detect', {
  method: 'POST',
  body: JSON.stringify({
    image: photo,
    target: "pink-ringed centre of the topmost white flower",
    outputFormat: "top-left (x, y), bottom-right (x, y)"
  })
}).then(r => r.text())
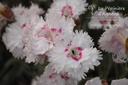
top-left (61, 6), bottom-right (73, 17)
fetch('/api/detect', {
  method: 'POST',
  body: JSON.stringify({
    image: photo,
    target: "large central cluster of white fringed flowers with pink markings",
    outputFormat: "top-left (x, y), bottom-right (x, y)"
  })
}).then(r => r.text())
top-left (3, 0), bottom-right (102, 85)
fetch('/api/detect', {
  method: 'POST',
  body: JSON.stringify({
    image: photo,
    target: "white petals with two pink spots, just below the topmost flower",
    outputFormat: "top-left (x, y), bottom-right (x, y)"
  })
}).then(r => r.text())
top-left (46, 13), bottom-right (75, 42)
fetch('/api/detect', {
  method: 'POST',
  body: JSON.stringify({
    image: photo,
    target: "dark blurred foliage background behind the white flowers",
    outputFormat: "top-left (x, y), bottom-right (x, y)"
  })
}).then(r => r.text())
top-left (0, 0), bottom-right (128, 85)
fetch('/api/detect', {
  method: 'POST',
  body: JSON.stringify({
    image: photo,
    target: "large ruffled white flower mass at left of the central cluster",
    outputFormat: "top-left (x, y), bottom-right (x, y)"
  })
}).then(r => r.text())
top-left (3, 15), bottom-right (53, 63)
